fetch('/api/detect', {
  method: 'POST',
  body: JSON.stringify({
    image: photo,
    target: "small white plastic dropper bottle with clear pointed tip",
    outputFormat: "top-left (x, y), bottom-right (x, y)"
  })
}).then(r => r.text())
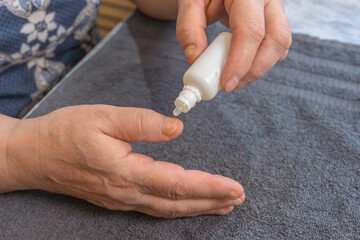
top-left (173, 32), bottom-right (232, 116)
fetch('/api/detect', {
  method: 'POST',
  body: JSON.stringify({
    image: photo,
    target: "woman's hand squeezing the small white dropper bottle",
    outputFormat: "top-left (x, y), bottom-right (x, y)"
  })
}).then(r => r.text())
top-left (176, 0), bottom-right (291, 92)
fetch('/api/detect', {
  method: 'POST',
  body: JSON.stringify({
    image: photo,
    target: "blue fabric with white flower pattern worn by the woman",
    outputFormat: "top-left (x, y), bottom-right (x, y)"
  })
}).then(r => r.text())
top-left (0, 0), bottom-right (101, 117)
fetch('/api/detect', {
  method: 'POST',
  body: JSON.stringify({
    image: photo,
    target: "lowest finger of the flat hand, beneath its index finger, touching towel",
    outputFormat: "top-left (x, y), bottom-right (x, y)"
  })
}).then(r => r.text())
top-left (137, 194), bottom-right (245, 218)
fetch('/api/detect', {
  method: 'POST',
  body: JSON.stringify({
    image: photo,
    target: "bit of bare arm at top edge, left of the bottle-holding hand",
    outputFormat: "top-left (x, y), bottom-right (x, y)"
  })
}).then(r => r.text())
top-left (132, 0), bottom-right (178, 20)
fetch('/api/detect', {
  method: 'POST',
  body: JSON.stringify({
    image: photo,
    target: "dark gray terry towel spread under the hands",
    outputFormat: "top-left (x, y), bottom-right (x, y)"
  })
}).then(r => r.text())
top-left (0, 10), bottom-right (360, 239)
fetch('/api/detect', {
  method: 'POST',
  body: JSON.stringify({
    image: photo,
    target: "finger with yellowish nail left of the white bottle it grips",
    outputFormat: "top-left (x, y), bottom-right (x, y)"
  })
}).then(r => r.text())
top-left (176, 0), bottom-right (207, 64)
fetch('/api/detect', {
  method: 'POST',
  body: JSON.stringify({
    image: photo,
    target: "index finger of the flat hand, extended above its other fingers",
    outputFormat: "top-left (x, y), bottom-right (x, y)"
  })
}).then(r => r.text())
top-left (128, 153), bottom-right (244, 200)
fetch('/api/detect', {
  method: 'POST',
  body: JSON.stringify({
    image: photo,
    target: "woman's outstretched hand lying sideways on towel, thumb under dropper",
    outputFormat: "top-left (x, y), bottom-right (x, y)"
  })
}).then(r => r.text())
top-left (0, 105), bottom-right (245, 218)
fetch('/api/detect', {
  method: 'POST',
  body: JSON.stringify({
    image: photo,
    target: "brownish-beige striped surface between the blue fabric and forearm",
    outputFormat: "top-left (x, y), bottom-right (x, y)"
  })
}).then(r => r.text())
top-left (98, 0), bottom-right (136, 38)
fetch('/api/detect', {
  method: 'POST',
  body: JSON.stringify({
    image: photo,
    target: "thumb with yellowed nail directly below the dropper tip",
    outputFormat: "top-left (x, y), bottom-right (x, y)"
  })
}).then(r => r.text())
top-left (101, 107), bottom-right (183, 142)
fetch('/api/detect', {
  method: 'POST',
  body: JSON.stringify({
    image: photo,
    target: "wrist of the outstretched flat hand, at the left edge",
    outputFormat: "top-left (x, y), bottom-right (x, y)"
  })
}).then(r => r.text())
top-left (0, 115), bottom-right (45, 193)
